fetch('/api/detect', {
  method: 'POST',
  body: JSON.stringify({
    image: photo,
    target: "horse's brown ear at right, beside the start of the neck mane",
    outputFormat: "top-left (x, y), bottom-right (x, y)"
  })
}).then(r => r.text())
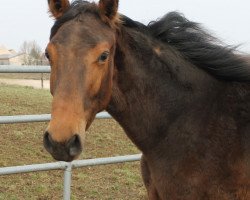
top-left (99, 0), bottom-right (119, 21)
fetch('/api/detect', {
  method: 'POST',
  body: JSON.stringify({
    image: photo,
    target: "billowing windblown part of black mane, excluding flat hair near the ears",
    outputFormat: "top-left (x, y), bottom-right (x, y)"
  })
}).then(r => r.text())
top-left (148, 12), bottom-right (250, 81)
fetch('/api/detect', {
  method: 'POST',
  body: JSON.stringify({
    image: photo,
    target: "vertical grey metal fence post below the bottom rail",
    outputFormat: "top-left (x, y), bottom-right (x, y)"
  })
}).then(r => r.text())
top-left (63, 163), bottom-right (72, 200)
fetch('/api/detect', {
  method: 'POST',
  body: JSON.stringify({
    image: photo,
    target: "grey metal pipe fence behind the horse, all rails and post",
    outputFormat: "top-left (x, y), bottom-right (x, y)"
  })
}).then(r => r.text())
top-left (0, 65), bottom-right (141, 200)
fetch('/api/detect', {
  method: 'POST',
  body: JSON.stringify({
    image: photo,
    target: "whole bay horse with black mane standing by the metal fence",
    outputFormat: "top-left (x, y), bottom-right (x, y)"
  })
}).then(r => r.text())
top-left (44, 0), bottom-right (250, 200)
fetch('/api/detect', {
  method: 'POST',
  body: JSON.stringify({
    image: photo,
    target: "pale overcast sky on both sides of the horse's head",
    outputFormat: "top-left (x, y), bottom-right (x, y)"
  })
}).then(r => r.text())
top-left (0, 0), bottom-right (250, 53)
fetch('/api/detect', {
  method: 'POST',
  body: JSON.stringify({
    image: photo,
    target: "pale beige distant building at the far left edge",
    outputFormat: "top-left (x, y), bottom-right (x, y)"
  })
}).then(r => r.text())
top-left (0, 46), bottom-right (25, 65)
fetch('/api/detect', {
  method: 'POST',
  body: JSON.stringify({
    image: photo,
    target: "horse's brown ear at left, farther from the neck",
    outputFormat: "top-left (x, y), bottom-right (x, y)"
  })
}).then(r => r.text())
top-left (48, 0), bottom-right (70, 19)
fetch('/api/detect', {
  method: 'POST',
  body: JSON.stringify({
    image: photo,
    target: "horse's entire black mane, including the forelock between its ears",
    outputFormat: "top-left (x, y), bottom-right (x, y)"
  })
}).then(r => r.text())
top-left (50, 0), bottom-right (250, 81)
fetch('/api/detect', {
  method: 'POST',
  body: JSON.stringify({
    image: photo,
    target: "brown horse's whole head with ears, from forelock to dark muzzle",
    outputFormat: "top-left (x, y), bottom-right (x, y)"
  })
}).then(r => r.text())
top-left (44, 0), bottom-right (119, 161)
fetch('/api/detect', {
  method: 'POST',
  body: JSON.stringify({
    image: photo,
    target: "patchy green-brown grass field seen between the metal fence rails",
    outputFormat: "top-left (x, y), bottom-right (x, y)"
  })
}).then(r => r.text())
top-left (0, 85), bottom-right (146, 200)
